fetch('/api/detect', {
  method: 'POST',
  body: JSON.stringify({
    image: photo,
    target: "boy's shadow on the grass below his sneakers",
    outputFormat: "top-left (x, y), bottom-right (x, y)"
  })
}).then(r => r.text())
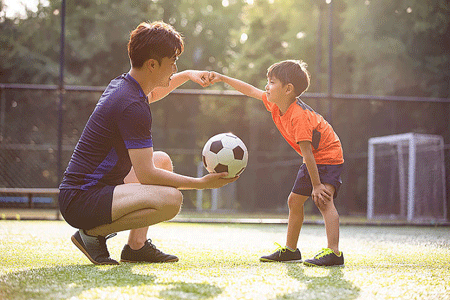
top-left (276, 264), bottom-right (360, 300)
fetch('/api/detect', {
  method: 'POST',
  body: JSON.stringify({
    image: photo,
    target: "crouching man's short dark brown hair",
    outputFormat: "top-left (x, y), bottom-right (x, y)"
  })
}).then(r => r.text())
top-left (128, 21), bottom-right (184, 68)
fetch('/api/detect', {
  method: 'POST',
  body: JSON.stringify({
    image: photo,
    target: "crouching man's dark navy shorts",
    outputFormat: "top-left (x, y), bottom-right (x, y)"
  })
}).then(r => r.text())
top-left (58, 186), bottom-right (115, 230)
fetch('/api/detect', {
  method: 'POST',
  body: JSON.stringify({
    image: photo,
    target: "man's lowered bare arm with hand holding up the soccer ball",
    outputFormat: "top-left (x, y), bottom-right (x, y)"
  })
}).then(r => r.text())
top-left (128, 148), bottom-right (238, 189)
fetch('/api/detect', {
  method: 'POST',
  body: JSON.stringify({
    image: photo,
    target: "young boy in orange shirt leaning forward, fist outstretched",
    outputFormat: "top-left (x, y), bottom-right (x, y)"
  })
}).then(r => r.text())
top-left (209, 60), bottom-right (344, 266)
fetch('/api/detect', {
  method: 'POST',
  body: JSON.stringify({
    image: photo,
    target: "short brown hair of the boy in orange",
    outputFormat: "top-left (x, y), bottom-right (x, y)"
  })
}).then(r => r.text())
top-left (267, 60), bottom-right (310, 97)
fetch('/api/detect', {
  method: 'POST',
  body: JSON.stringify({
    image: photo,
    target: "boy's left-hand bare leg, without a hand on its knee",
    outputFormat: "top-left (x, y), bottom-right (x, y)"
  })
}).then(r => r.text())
top-left (286, 192), bottom-right (308, 249)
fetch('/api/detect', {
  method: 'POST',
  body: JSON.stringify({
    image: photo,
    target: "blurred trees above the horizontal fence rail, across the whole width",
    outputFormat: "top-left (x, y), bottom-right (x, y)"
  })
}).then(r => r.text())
top-left (0, 0), bottom-right (450, 97)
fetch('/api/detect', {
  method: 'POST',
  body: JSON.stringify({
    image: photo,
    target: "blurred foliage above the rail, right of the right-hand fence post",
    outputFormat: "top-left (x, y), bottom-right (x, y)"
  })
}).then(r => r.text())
top-left (337, 0), bottom-right (450, 97)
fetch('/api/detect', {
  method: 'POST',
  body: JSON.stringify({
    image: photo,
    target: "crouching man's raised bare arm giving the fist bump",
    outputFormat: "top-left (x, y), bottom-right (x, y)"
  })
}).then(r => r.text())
top-left (148, 70), bottom-right (209, 103)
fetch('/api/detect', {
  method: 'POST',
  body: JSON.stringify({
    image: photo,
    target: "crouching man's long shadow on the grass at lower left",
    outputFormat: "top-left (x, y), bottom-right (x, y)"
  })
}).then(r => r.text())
top-left (0, 264), bottom-right (222, 300)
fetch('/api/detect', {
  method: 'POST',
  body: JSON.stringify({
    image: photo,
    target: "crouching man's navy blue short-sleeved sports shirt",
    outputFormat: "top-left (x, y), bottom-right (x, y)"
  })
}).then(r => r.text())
top-left (60, 73), bottom-right (153, 190)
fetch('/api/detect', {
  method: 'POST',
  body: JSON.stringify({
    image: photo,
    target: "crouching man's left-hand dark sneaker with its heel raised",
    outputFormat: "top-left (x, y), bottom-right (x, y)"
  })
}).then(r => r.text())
top-left (72, 229), bottom-right (119, 265)
